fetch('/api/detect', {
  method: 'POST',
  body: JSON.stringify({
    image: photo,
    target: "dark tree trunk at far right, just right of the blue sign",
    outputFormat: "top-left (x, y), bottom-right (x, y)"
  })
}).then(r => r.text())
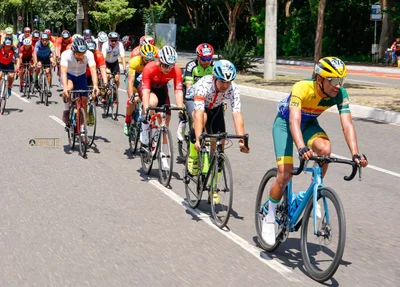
top-left (379, 0), bottom-right (395, 58)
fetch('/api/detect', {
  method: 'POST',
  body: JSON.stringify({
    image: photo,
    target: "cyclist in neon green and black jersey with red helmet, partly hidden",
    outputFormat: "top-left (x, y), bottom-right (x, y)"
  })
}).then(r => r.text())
top-left (177, 43), bottom-right (214, 141)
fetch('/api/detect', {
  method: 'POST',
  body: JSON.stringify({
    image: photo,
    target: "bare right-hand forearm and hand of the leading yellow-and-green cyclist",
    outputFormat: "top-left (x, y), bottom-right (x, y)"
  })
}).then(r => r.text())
top-left (340, 113), bottom-right (368, 167)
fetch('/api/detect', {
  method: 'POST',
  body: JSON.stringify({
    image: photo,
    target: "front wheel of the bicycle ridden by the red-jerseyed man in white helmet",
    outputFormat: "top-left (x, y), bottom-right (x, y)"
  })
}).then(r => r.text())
top-left (158, 126), bottom-right (174, 186)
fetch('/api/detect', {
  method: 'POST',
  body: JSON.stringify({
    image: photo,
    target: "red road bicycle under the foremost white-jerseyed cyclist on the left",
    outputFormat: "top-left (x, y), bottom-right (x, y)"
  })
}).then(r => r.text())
top-left (65, 90), bottom-right (94, 158)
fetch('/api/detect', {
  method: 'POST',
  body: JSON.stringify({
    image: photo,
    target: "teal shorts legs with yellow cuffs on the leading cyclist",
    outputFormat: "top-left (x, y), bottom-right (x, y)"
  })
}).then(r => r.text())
top-left (272, 115), bottom-right (329, 165)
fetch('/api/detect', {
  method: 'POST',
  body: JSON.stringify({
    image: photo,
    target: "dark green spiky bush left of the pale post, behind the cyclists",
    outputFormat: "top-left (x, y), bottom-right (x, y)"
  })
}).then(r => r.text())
top-left (219, 41), bottom-right (255, 72)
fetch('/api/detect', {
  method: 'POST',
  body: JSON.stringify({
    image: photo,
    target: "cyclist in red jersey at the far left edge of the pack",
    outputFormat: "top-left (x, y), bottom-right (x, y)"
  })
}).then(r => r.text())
top-left (0, 37), bottom-right (18, 97)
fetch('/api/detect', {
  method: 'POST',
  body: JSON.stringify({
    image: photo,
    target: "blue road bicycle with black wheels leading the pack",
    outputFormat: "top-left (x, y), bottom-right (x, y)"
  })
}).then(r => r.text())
top-left (255, 156), bottom-right (361, 282)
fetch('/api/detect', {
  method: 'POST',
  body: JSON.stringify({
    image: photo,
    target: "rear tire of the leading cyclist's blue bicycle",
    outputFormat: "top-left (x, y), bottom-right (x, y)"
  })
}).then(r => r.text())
top-left (254, 168), bottom-right (287, 252)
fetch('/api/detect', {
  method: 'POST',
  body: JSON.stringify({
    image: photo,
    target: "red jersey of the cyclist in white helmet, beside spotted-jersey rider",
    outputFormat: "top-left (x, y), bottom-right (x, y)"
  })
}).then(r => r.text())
top-left (142, 61), bottom-right (182, 90)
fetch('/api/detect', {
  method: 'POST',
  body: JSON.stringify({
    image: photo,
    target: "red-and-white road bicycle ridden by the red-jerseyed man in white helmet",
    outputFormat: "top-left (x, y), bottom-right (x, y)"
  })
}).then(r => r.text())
top-left (140, 104), bottom-right (183, 187)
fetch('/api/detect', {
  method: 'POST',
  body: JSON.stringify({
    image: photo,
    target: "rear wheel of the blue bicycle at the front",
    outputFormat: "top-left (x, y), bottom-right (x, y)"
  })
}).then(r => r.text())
top-left (255, 168), bottom-right (287, 252)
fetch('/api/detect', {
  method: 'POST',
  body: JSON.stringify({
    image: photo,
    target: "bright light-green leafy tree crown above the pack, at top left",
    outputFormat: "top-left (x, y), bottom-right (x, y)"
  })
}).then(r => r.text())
top-left (89, 0), bottom-right (136, 31)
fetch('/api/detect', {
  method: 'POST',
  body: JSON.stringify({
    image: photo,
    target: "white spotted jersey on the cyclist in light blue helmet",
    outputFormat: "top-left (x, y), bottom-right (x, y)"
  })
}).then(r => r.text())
top-left (194, 75), bottom-right (241, 113)
